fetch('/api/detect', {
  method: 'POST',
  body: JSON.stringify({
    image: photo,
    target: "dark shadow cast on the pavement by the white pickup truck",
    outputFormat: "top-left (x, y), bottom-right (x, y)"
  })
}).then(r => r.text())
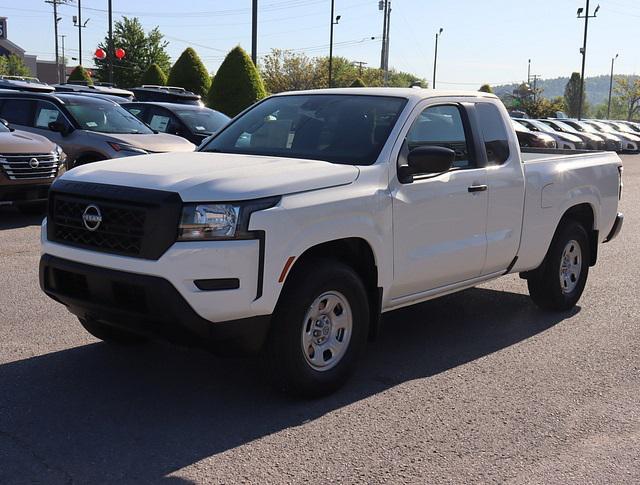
top-left (0, 289), bottom-right (579, 483)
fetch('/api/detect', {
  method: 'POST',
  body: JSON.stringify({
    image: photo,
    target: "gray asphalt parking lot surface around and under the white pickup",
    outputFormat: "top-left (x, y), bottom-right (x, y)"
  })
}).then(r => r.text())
top-left (0, 156), bottom-right (640, 484)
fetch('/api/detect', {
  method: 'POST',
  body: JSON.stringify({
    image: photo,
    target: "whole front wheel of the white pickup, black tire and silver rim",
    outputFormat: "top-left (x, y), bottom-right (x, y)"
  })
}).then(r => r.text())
top-left (264, 260), bottom-right (369, 397)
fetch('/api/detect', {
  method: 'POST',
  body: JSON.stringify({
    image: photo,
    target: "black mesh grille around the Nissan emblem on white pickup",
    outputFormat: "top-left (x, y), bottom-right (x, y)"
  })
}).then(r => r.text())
top-left (53, 196), bottom-right (146, 256)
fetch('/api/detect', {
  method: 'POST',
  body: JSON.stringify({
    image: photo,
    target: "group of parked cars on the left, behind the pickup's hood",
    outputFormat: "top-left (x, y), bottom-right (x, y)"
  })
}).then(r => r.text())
top-left (0, 78), bottom-right (230, 212)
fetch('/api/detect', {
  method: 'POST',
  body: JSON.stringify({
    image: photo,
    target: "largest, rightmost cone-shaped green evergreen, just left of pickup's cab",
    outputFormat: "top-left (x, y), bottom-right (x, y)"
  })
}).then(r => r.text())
top-left (209, 46), bottom-right (267, 117)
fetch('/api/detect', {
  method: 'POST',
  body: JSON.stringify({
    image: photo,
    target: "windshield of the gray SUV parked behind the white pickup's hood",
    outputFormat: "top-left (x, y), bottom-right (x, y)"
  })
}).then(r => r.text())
top-left (66, 100), bottom-right (153, 134)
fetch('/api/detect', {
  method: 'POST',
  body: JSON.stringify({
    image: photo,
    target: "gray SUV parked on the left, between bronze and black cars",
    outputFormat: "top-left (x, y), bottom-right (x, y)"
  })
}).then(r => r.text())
top-left (0, 91), bottom-right (195, 168)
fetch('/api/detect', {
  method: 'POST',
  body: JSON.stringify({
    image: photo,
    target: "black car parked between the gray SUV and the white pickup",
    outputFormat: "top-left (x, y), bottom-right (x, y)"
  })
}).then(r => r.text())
top-left (122, 103), bottom-right (231, 145)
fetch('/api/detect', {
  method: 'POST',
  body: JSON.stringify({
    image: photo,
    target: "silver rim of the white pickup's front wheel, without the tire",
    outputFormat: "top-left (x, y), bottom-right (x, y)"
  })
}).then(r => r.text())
top-left (301, 291), bottom-right (353, 372)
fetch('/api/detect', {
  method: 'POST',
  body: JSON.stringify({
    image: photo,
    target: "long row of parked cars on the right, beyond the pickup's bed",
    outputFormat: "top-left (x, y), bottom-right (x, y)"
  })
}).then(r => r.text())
top-left (512, 114), bottom-right (640, 153)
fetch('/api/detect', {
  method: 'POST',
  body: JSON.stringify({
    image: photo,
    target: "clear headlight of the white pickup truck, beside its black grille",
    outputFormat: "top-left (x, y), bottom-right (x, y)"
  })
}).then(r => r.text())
top-left (178, 197), bottom-right (280, 241)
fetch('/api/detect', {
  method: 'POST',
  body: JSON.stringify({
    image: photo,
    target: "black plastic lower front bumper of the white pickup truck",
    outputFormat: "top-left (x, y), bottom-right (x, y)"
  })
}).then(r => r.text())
top-left (40, 254), bottom-right (271, 351)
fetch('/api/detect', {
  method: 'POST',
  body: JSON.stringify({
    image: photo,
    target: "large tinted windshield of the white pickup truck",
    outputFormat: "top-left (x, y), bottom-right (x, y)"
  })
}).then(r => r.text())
top-left (202, 94), bottom-right (407, 165)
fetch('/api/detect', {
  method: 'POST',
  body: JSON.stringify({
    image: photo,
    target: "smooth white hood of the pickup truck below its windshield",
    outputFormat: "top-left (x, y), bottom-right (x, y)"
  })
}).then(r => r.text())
top-left (62, 152), bottom-right (360, 202)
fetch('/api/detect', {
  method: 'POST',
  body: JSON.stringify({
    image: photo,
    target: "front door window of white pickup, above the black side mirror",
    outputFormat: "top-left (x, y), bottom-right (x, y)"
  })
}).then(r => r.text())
top-left (406, 105), bottom-right (475, 168)
